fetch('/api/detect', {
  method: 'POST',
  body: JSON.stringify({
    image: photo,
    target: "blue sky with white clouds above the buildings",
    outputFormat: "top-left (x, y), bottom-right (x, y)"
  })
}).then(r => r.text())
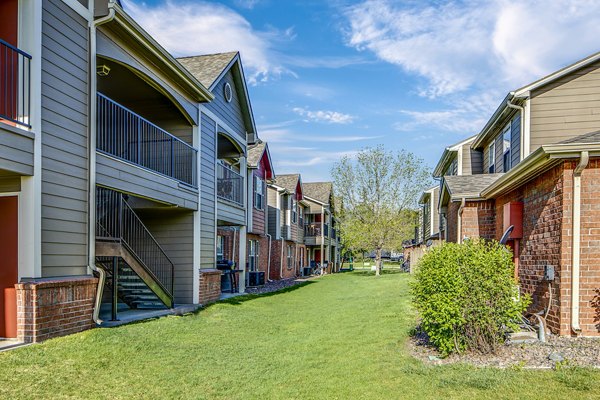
top-left (123, 0), bottom-right (600, 181)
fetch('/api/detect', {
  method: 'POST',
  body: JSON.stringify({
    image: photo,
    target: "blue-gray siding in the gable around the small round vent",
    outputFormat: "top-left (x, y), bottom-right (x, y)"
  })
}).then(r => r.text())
top-left (206, 71), bottom-right (246, 143)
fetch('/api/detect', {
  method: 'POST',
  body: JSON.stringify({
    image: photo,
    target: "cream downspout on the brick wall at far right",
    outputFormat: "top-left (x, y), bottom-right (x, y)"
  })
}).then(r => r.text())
top-left (571, 151), bottom-right (590, 334)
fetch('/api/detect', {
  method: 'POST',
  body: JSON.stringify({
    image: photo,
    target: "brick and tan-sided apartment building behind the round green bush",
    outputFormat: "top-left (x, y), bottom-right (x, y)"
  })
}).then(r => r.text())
top-left (428, 53), bottom-right (600, 336)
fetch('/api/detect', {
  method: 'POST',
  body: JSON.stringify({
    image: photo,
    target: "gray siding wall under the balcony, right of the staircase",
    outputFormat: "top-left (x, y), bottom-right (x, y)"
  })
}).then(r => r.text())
top-left (141, 212), bottom-right (194, 304)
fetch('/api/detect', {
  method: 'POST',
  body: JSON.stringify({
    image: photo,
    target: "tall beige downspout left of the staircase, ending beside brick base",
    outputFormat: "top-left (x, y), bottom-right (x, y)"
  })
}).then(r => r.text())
top-left (88, 2), bottom-right (115, 325)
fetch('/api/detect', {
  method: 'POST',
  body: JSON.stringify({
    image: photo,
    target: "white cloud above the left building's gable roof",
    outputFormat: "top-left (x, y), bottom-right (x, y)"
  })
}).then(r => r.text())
top-left (120, 0), bottom-right (290, 84)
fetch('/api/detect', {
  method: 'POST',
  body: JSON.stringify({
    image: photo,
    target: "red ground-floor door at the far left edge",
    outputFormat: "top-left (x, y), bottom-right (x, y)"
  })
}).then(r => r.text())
top-left (0, 196), bottom-right (19, 338)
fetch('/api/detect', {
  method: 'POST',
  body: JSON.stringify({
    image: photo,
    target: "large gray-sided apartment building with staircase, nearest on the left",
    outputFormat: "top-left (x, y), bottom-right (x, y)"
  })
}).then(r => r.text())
top-left (0, 0), bottom-right (264, 342)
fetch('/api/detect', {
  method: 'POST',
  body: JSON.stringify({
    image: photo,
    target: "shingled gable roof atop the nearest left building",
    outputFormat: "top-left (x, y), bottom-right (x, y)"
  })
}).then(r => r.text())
top-left (177, 51), bottom-right (256, 138)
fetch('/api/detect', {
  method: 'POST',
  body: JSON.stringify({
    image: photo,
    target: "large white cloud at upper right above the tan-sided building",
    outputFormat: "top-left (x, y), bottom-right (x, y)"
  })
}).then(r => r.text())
top-left (345, 0), bottom-right (600, 97)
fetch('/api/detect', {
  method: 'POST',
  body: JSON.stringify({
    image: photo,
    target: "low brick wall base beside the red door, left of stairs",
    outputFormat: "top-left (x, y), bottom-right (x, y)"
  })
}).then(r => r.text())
top-left (15, 277), bottom-right (98, 343)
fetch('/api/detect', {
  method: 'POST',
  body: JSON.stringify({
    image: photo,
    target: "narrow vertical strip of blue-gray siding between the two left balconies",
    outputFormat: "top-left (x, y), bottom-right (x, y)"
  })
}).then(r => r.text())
top-left (200, 114), bottom-right (217, 268)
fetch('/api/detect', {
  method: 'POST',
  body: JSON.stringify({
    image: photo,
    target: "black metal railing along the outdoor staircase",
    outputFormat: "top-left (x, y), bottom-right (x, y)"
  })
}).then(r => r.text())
top-left (96, 188), bottom-right (175, 299)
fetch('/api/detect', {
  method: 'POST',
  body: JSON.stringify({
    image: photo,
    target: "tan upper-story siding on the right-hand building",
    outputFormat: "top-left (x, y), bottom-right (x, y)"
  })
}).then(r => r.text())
top-left (530, 62), bottom-right (600, 152)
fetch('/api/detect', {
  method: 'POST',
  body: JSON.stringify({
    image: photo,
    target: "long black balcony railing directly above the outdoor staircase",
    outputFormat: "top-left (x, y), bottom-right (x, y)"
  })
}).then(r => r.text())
top-left (96, 93), bottom-right (198, 187)
